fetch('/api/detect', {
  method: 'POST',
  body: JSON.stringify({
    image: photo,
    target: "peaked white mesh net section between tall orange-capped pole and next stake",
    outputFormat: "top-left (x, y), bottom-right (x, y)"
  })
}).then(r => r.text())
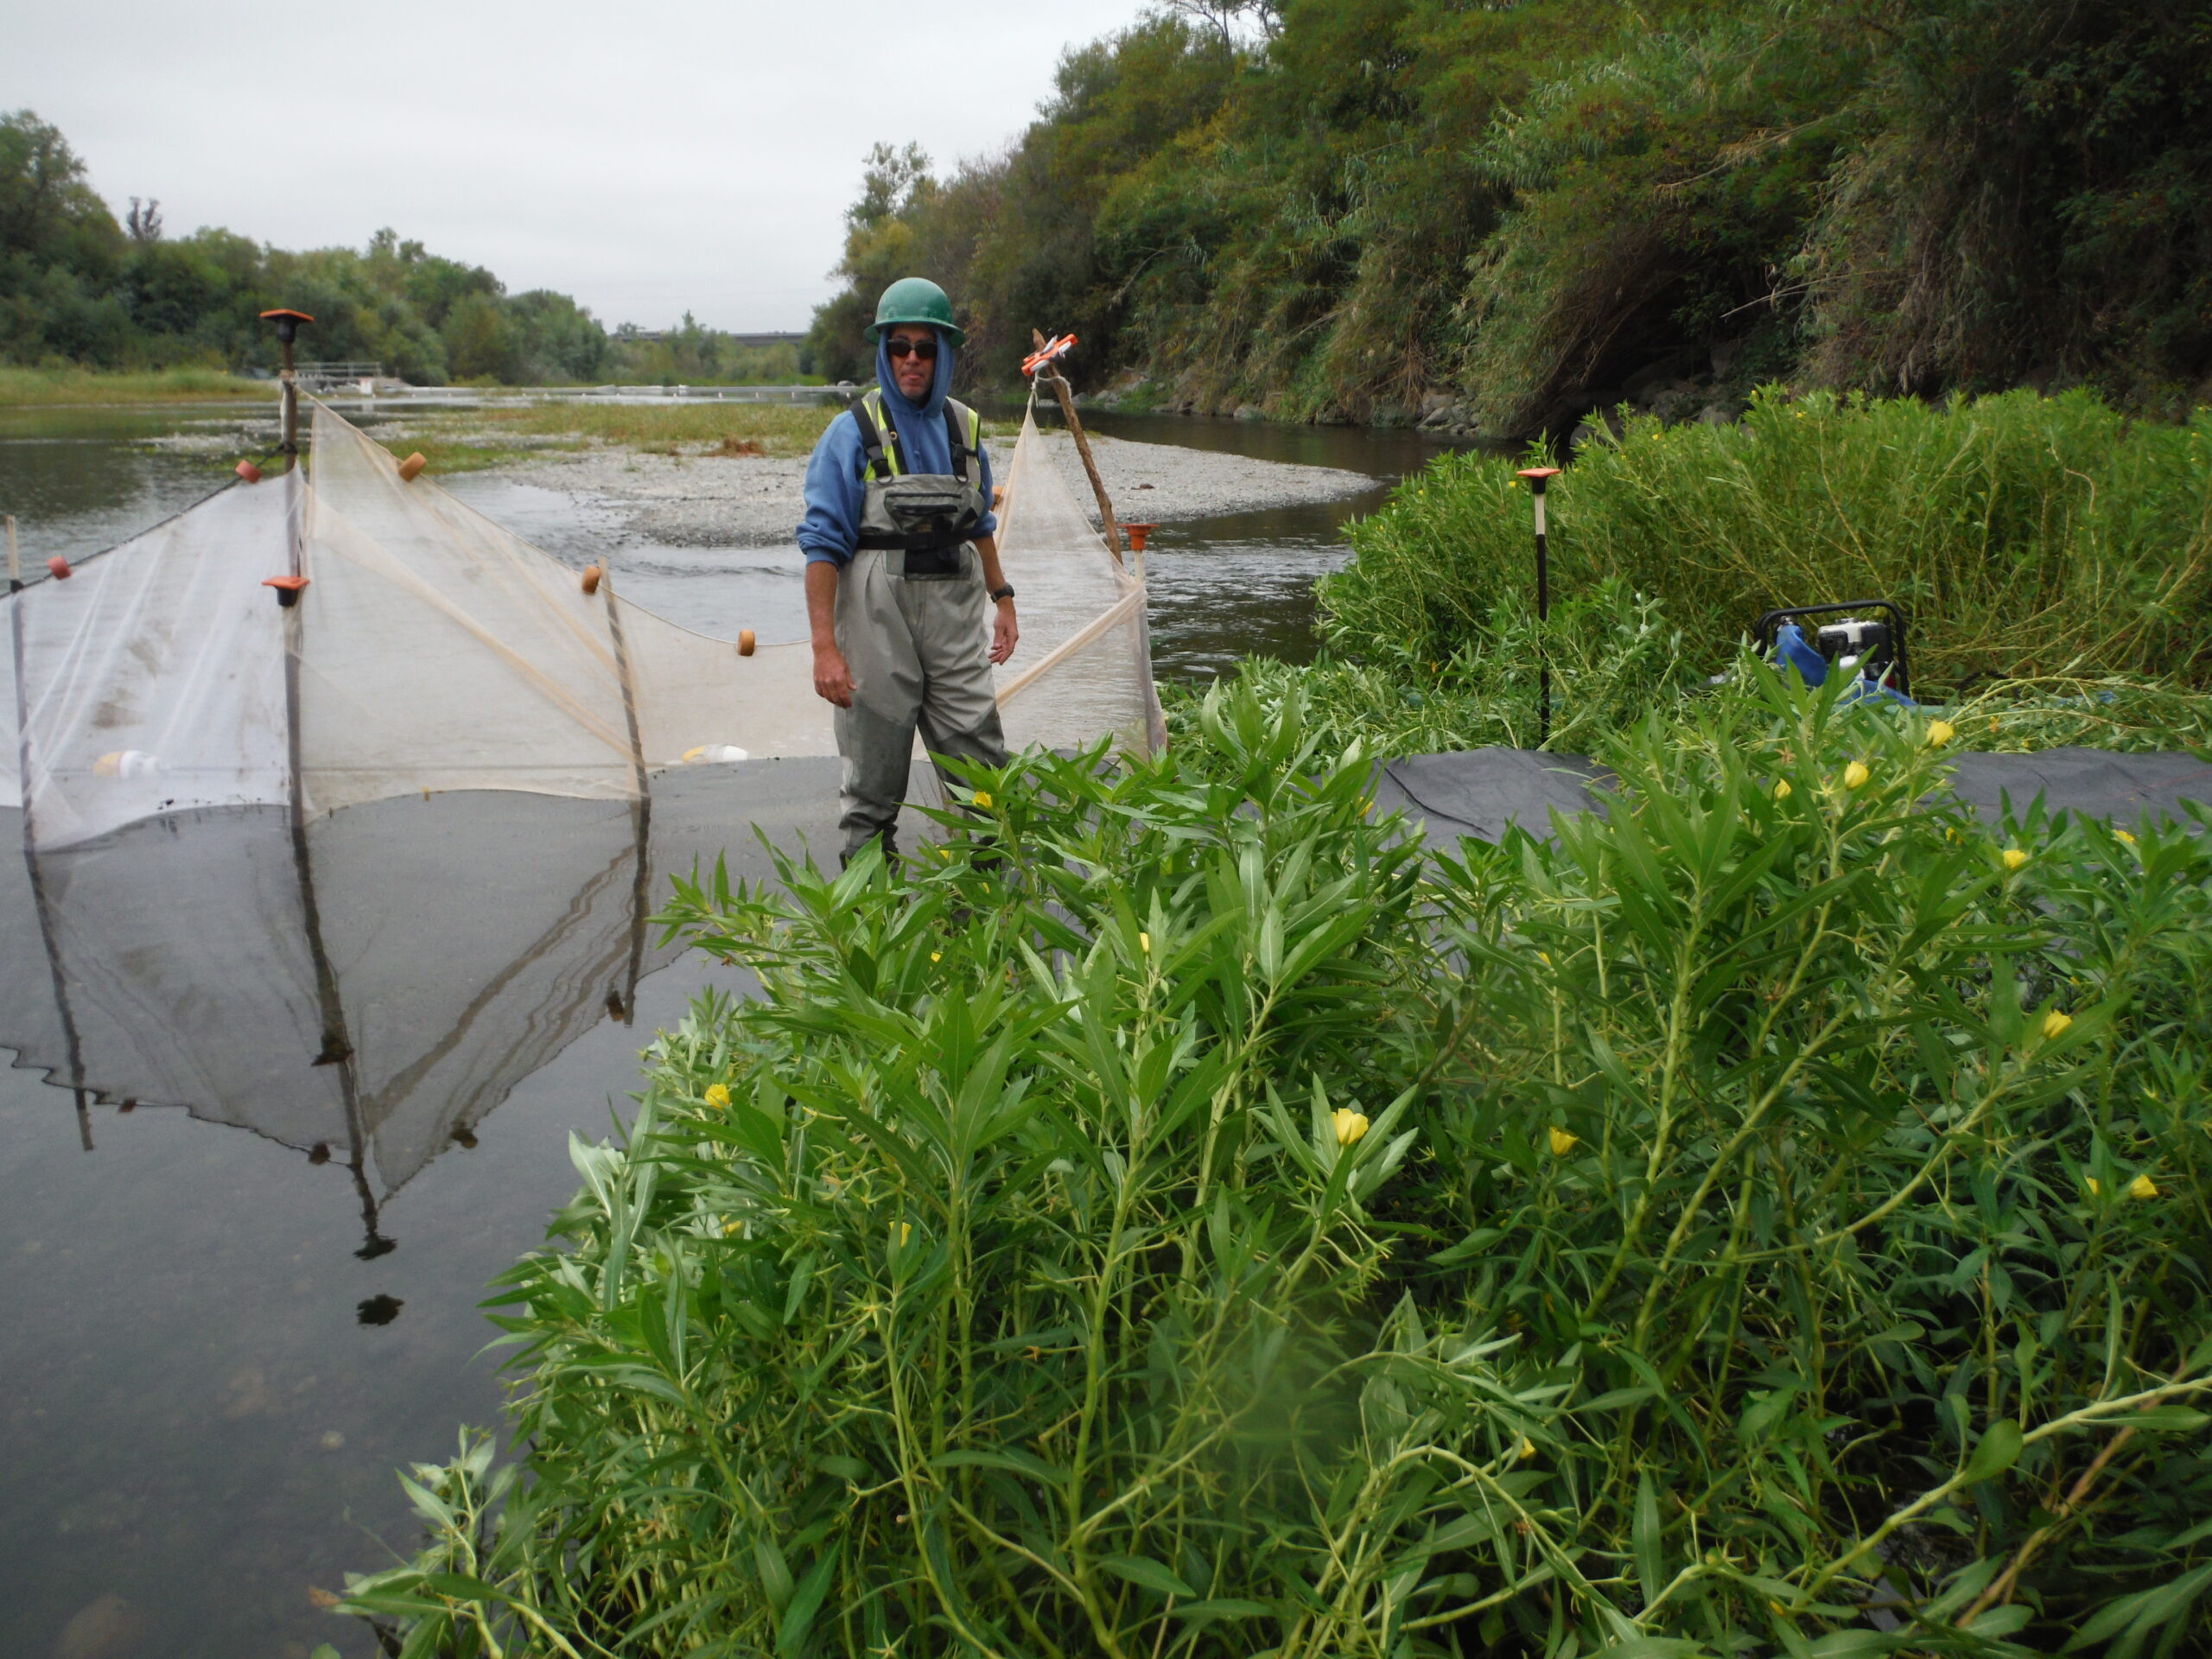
top-left (299, 407), bottom-right (637, 812)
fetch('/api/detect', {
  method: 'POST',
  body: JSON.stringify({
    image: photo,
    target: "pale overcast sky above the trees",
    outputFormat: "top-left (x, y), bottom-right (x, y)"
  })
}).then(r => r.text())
top-left (0, 0), bottom-right (1146, 329)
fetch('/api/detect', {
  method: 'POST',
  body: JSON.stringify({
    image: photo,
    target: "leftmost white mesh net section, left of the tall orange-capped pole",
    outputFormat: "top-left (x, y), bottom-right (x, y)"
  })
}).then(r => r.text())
top-left (0, 475), bottom-right (301, 847)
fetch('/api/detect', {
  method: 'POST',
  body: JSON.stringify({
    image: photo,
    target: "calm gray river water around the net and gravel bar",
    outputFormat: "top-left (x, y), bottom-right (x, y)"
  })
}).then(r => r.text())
top-left (0, 410), bottom-right (1435, 1659)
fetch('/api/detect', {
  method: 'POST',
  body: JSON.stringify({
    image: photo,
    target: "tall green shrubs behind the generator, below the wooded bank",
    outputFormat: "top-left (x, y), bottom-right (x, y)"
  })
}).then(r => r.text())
top-left (1320, 391), bottom-right (2212, 690)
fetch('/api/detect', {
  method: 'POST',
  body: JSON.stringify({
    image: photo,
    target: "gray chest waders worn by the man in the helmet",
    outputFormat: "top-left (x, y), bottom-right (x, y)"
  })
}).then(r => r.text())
top-left (836, 390), bottom-right (1007, 858)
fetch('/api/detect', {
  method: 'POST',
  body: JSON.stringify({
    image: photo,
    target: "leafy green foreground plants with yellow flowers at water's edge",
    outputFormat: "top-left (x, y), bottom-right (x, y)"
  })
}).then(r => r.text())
top-left (349, 666), bottom-right (2212, 1659)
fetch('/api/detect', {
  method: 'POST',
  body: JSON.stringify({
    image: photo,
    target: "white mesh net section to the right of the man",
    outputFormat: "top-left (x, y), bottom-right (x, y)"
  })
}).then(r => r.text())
top-left (998, 414), bottom-right (1166, 754)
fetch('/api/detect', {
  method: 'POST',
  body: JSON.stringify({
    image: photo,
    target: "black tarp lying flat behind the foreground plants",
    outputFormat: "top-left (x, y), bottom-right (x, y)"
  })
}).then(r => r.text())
top-left (1376, 747), bottom-right (2212, 845)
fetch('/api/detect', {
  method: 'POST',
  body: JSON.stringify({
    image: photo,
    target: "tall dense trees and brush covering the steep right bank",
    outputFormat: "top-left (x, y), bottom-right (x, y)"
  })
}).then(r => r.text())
top-left (814, 0), bottom-right (2212, 435)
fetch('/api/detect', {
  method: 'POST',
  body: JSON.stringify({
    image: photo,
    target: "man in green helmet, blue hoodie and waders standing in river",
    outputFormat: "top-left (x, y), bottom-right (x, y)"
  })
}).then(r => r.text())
top-left (798, 276), bottom-right (1020, 862)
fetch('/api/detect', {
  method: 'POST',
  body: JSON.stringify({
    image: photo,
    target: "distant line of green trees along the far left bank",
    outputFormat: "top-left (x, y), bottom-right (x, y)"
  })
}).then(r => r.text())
top-left (0, 111), bottom-right (803, 400)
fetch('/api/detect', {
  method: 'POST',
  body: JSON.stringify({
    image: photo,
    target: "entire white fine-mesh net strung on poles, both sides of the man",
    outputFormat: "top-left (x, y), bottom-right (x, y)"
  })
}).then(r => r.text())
top-left (0, 407), bottom-right (1164, 849)
